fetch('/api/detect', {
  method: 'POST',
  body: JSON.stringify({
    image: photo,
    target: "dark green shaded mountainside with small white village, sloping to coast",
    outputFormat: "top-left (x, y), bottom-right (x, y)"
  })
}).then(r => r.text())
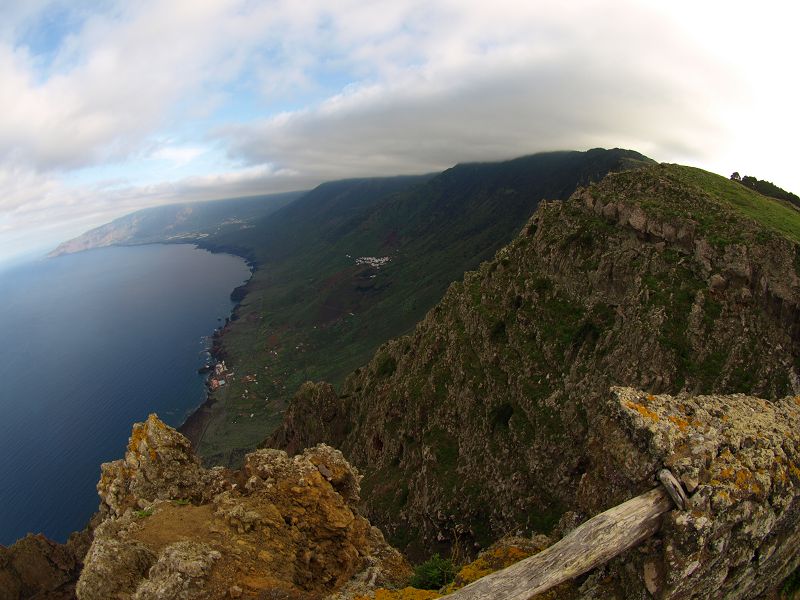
top-left (193, 149), bottom-right (651, 463)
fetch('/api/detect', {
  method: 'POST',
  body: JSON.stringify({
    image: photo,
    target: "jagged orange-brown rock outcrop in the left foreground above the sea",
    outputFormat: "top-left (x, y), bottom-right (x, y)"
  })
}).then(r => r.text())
top-left (77, 415), bottom-right (409, 600)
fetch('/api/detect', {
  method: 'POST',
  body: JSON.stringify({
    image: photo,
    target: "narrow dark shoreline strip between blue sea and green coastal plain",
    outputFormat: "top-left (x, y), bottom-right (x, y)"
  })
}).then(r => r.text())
top-left (175, 242), bottom-right (258, 452)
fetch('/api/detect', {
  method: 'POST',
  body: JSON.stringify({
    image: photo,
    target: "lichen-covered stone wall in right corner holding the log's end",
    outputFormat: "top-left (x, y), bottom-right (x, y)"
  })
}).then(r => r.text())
top-left (579, 388), bottom-right (800, 599)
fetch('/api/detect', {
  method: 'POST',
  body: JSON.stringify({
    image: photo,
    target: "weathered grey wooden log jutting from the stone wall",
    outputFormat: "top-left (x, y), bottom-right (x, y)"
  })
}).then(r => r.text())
top-left (447, 484), bottom-right (680, 600)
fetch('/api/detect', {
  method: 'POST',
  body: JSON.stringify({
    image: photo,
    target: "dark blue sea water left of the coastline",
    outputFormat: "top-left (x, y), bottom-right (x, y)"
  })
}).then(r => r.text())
top-left (0, 245), bottom-right (250, 545)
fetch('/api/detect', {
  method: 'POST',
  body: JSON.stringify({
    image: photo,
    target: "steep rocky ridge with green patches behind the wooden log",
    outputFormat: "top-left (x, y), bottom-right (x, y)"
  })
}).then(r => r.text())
top-left (271, 165), bottom-right (800, 552)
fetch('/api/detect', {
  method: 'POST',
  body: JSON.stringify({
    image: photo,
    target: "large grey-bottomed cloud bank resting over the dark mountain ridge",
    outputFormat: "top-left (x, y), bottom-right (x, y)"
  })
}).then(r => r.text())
top-left (217, 3), bottom-right (738, 178)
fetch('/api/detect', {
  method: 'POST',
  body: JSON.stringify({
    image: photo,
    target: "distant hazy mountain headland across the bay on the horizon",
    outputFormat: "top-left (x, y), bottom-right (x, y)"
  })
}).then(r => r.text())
top-left (49, 192), bottom-right (304, 257)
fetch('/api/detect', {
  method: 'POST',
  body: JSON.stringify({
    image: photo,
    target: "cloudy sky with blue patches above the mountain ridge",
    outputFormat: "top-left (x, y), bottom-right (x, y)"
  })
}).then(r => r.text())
top-left (0, 0), bottom-right (800, 262)
